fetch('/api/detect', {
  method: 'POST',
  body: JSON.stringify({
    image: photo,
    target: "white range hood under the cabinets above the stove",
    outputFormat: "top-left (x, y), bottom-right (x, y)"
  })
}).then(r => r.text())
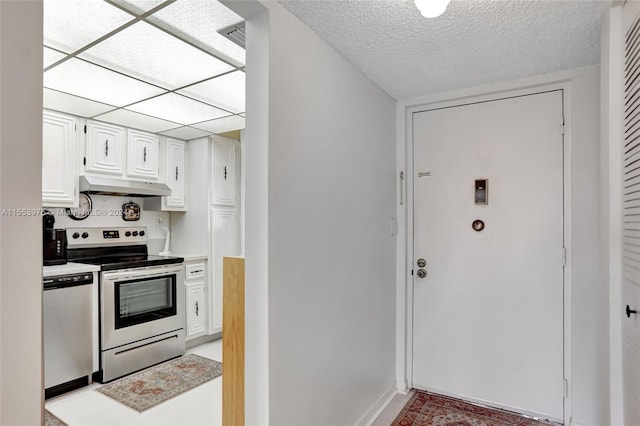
top-left (80, 175), bottom-right (171, 197)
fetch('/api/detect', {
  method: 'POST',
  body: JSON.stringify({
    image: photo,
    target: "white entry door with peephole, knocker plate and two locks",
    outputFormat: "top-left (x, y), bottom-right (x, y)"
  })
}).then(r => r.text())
top-left (413, 90), bottom-right (564, 421)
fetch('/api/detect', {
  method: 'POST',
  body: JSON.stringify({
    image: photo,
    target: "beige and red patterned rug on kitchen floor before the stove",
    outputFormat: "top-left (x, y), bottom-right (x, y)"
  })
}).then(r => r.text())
top-left (96, 354), bottom-right (222, 411)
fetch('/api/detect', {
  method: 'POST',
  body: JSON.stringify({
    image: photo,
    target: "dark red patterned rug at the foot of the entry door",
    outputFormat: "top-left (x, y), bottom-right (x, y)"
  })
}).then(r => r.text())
top-left (391, 390), bottom-right (552, 426)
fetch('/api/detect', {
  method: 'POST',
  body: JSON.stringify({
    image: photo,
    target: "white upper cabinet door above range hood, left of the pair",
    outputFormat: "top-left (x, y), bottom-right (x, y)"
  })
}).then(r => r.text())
top-left (85, 120), bottom-right (125, 176)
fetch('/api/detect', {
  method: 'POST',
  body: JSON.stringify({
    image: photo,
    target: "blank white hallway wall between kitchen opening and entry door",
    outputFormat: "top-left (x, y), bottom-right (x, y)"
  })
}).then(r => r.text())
top-left (245, 2), bottom-right (395, 425)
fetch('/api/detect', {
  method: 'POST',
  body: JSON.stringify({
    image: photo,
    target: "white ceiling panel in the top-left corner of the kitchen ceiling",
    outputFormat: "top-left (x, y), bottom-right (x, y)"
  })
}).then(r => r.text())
top-left (43, 0), bottom-right (133, 53)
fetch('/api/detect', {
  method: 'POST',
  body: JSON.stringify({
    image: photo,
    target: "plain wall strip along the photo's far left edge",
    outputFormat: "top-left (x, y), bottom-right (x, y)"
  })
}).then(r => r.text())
top-left (0, 1), bottom-right (43, 425)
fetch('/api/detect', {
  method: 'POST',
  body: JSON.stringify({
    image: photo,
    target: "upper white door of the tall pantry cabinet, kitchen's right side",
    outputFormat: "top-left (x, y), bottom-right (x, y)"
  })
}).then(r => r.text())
top-left (211, 139), bottom-right (236, 206)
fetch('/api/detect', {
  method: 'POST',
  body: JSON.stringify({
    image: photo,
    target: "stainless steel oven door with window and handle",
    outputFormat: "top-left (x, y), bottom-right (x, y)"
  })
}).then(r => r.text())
top-left (100, 265), bottom-right (185, 351)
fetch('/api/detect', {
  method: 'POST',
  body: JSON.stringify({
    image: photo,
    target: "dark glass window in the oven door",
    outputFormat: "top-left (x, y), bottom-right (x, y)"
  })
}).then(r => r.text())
top-left (114, 275), bottom-right (177, 329)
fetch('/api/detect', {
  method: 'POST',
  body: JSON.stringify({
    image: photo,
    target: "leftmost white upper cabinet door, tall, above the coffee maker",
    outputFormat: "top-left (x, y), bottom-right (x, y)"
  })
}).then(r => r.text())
top-left (42, 111), bottom-right (78, 207)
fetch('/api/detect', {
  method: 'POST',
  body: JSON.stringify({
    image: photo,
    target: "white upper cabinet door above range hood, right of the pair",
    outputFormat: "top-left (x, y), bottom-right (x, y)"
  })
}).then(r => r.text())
top-left (127, 130), bottom-right (159, 180)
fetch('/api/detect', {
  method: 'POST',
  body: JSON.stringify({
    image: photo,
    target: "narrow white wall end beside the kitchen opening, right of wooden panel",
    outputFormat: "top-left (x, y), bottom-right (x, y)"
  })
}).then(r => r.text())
top-left (241, 5), bottom-right (270, 425)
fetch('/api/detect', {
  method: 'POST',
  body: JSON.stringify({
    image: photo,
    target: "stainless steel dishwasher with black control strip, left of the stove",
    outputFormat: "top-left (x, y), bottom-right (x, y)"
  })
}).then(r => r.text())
top-left (42, 272), bottom-right (94, 398)
